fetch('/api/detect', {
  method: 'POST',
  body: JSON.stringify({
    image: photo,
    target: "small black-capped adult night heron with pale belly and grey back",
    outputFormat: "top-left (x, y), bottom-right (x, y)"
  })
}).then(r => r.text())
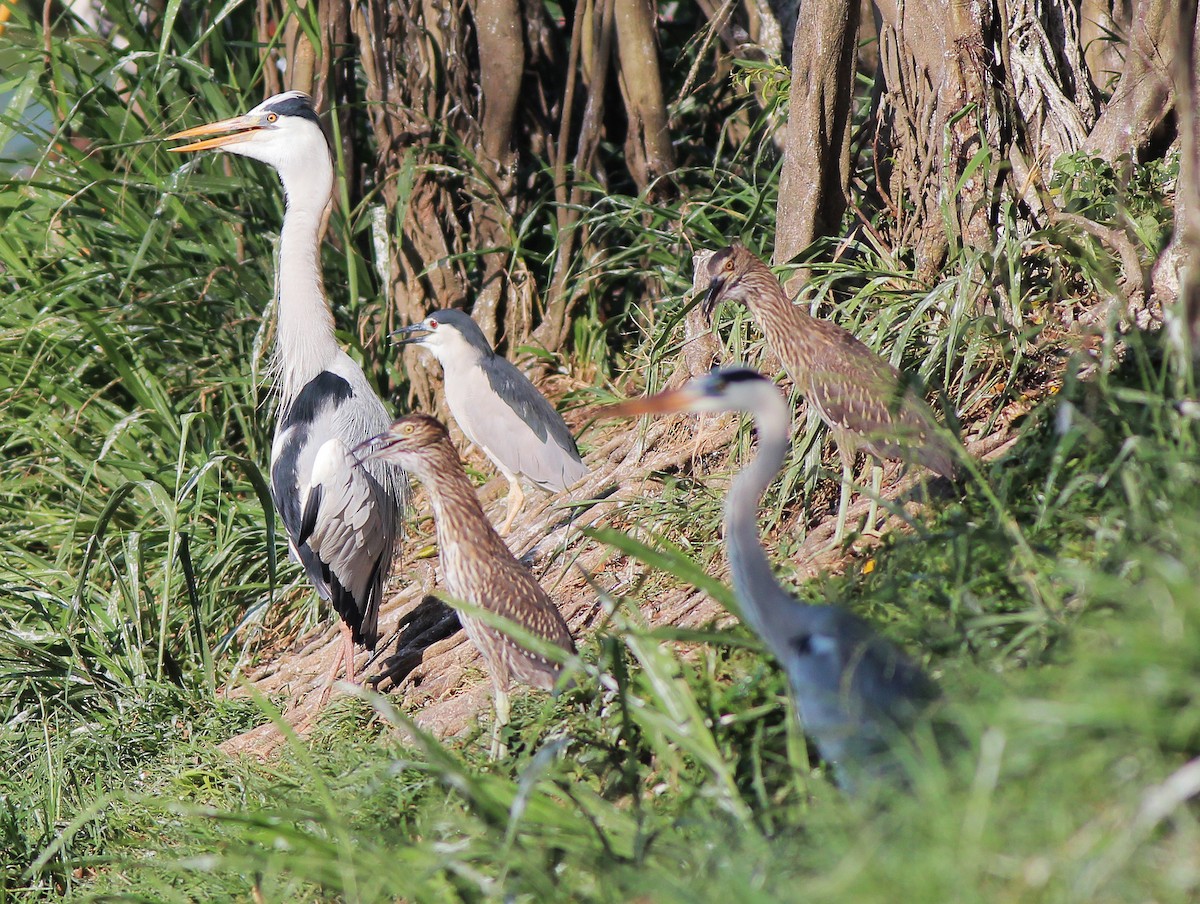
top-left (391, 310), bottom-right (588, 534)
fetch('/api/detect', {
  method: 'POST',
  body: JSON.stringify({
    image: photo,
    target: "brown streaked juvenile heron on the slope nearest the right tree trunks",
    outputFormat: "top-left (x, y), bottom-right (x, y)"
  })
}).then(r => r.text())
top-left (704, 243), bottom-right (955, 543)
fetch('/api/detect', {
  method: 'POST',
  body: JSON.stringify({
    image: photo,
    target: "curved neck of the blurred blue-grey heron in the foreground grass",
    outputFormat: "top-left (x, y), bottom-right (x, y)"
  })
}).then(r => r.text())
top-left (725, 387), bottom-right (791, 649)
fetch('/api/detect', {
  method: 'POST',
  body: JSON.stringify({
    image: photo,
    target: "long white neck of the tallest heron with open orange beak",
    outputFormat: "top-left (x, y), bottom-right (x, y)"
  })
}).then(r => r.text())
top-left (276, 164), bottom-right (341, 402)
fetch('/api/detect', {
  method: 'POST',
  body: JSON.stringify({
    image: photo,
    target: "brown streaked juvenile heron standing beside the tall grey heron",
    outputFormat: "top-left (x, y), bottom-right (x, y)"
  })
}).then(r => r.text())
top-left (356, 414), bottom-right (575, 758)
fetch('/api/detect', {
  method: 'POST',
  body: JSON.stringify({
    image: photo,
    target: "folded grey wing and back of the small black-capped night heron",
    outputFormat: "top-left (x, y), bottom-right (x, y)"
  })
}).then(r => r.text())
top-left (477, 355), bottom-right (588, 490)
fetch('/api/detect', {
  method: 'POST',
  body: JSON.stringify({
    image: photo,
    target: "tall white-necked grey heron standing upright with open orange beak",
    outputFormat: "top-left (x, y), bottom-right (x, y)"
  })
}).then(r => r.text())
top-left (168, 91), bottom-right (408, 693)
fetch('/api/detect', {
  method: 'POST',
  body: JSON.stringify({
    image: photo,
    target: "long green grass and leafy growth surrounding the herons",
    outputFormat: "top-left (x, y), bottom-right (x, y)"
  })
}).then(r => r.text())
top-left (0, 4), bottom-right (1200, 902)
